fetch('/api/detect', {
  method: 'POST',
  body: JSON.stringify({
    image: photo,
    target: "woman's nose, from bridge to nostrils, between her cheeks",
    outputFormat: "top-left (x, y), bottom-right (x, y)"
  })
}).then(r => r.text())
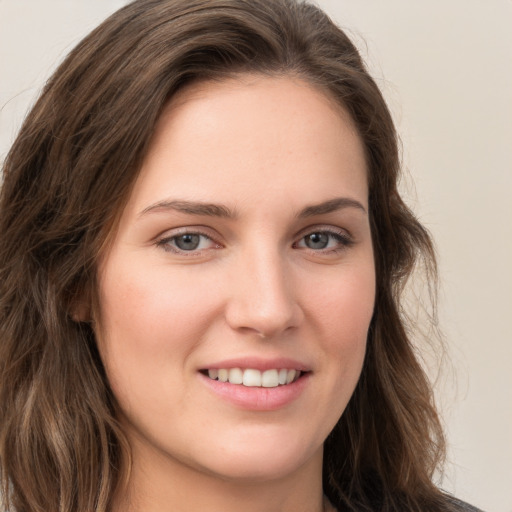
top-left (226, 245), bottom-right (304, 338)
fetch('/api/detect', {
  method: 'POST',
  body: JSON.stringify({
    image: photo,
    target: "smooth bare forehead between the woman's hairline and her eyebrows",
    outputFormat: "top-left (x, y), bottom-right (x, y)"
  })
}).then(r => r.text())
top-left (126, 75), bottom-right (367, 214)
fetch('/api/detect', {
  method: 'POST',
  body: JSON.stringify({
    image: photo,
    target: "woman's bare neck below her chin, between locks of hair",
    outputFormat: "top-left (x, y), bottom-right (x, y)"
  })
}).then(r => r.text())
top-left (112, 438), bottom-right (328, 512)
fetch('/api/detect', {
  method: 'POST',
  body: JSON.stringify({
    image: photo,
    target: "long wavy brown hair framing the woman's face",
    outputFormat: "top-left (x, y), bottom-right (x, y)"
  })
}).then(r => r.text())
top-left (0, 0), bottom-right (450, 512)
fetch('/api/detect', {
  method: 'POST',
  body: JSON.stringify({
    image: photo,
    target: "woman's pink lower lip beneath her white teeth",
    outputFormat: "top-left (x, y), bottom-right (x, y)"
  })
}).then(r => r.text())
top-left (199, 373), bottom-right (310, 411)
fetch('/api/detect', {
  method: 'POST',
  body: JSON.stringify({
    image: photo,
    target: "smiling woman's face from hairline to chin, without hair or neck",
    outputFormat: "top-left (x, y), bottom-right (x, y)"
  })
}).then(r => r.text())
top-left (96, 76), bottom-right (375, 479)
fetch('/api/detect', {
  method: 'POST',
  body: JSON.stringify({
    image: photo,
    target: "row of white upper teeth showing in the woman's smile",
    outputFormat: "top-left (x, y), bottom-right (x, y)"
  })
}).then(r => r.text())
top-left (208, 368), bottom-right (301, 388)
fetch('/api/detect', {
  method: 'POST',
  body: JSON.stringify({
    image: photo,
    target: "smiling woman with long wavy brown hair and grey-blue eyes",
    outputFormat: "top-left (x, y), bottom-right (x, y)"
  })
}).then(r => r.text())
top-left (0, 0), bottom-right (480, 512)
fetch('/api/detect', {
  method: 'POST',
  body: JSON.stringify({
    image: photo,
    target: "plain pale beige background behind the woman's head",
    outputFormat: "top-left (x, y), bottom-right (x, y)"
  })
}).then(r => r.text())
top-left (0, 0), bottom-right (512, 512)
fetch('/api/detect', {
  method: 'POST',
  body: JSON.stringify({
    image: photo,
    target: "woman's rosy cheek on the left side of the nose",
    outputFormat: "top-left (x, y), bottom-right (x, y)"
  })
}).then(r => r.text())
top-left (96, 259), bottom-right (216, 408)
